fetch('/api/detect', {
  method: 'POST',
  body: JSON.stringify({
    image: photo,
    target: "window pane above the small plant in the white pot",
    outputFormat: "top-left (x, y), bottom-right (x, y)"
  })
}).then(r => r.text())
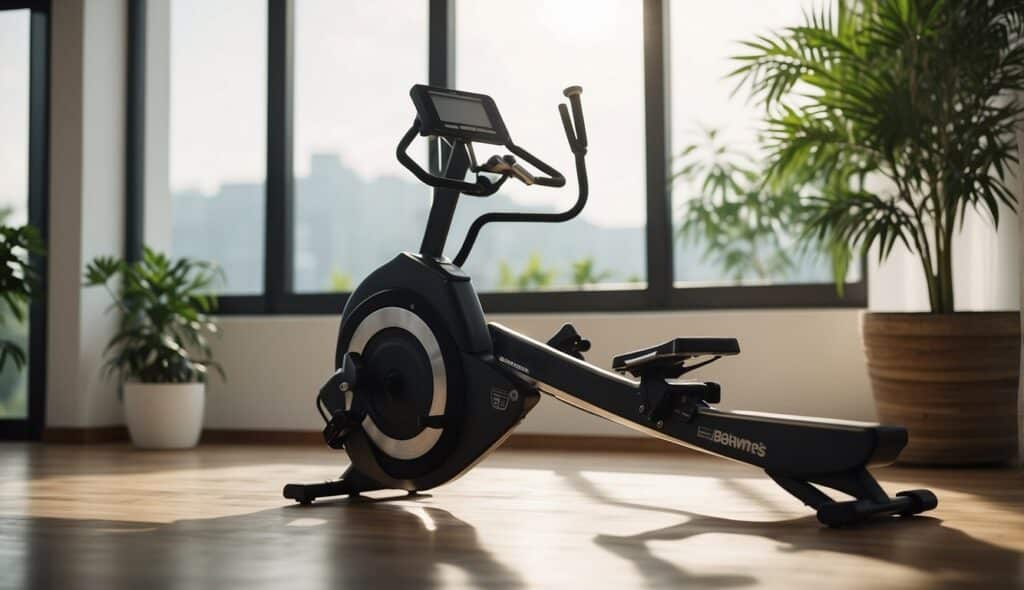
top-left (170, 0), bottom-right (266, 294)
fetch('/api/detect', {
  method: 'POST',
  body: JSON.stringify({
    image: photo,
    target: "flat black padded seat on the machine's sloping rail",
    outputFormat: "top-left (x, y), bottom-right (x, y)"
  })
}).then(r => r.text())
top-left (611, 338), bottom-right (739, 378)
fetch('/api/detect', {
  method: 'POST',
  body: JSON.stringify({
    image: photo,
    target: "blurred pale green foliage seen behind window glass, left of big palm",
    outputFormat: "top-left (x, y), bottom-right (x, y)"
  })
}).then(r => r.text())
top-left (670, 129), bottom-right (804, 281)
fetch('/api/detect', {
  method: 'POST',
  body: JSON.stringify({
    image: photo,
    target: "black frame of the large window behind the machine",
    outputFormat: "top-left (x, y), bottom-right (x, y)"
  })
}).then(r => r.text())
top-left (125, 0), bottom-right (867, 315)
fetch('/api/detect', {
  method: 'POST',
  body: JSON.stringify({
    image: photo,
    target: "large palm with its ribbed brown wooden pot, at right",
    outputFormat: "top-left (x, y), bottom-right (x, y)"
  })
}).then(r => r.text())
top-left (733, 0), bottom-right (1024, 464)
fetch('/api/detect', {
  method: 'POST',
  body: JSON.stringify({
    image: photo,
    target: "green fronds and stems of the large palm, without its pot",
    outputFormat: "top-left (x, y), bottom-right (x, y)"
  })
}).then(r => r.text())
top-left (732, 0), bottom-right (1024, 312)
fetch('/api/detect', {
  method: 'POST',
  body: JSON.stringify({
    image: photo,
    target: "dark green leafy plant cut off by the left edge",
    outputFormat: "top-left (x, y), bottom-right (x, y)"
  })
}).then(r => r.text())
top-left (0, 223), bottom-right (44, 370)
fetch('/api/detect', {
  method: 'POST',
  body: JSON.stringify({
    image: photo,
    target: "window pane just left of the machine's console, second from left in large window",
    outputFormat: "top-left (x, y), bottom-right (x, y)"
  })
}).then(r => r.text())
top-left (294, 0), bottom-right (430, 292)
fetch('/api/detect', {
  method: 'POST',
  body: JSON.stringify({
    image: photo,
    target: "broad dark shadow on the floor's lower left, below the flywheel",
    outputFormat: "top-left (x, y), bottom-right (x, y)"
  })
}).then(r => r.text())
top-left (12, 499), bottom-right (525, 590)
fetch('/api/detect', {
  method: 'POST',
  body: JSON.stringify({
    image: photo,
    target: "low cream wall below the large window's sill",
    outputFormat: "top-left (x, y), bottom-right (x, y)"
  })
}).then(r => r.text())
top-left (206, 309), bottom-right (874, 435)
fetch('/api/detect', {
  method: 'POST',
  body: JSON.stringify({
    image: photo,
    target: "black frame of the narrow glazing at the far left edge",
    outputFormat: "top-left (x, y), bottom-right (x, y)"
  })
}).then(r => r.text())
top-left (0, 0), bottom-right (50, 440)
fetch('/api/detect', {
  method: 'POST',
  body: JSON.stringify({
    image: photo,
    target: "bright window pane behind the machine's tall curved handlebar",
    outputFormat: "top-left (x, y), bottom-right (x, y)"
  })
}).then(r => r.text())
top-left (458, 0), bottom-right (646, 291)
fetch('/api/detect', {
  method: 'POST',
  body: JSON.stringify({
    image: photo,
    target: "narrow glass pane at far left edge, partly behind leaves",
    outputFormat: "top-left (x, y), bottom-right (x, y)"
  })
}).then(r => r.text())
top-left (0, 6), bottom-right (30, 419)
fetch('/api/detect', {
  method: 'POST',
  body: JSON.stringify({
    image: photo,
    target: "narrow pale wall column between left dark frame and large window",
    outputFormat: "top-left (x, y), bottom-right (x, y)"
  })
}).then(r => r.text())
top-left (46, 0), bottom-right (126, 426)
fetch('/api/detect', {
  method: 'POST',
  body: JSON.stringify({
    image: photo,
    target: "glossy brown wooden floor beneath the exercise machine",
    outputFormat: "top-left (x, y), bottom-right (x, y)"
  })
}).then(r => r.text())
top-left (0, 445), bottom-right (1024, 590)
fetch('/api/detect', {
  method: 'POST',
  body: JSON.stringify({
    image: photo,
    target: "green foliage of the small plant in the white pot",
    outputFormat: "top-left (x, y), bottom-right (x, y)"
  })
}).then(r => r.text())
top-left (85, 248), bottom-right (223, 383)
